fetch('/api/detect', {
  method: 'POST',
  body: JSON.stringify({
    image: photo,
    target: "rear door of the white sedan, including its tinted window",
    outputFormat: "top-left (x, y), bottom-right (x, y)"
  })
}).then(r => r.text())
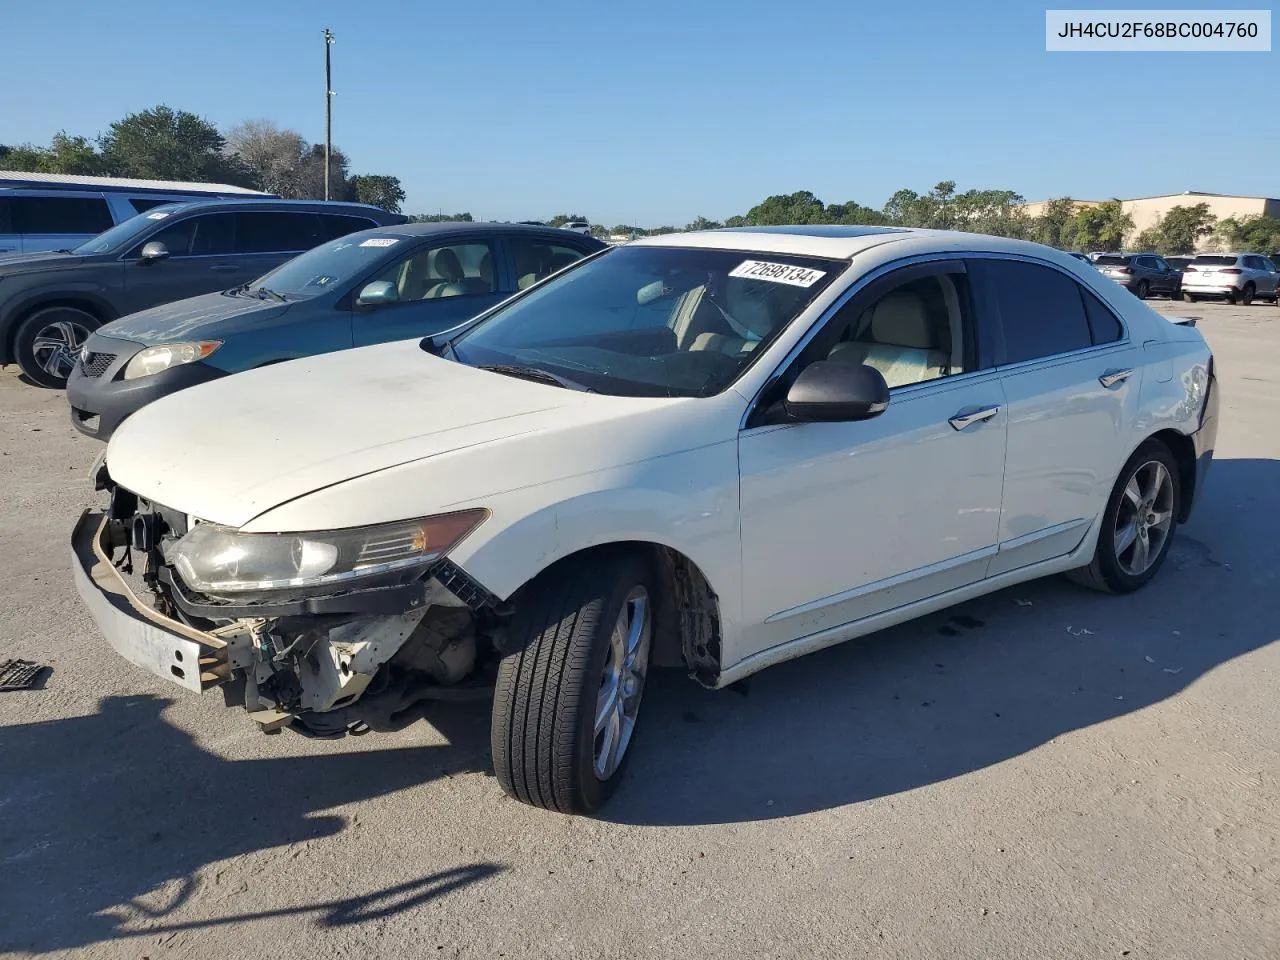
top-left (970, 257), bottom-right (1142, 576)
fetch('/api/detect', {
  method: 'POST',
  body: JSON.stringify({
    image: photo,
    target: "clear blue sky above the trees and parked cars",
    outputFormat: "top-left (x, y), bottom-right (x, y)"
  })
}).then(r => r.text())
top-left (0, 0), bottom-right (1280, 227)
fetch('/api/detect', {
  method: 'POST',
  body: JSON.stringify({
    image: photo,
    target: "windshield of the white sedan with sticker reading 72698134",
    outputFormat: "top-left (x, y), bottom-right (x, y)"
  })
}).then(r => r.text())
top-left (451, 247), bottom-right (845, 397)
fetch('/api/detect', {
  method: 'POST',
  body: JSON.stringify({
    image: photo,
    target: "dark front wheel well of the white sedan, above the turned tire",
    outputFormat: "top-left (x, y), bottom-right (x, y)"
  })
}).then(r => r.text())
top-left (513, 540), bottom-right (721, 687)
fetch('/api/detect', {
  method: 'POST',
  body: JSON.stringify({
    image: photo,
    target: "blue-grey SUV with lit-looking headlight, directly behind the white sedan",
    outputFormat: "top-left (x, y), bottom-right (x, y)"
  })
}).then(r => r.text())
top-left (67, 223), bottom-right (605, 440)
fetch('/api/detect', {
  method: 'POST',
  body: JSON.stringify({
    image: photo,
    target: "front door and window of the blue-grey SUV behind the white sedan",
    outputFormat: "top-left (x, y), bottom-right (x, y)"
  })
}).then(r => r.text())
top-left (351, 236), bottom-right (508, 347)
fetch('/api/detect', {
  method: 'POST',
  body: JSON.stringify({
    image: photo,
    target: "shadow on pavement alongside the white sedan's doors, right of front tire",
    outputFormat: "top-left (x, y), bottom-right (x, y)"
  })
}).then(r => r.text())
top-left (603, 460), bottom-right (1280, 824)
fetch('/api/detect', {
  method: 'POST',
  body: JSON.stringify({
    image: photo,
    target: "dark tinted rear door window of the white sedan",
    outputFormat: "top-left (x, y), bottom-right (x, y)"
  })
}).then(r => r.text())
top-left (983, 260), bottom-right (1093, 364)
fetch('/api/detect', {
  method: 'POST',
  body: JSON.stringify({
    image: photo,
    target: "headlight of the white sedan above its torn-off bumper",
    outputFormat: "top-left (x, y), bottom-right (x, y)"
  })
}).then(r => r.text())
top-left (166, 509), bottom-right (489, 594)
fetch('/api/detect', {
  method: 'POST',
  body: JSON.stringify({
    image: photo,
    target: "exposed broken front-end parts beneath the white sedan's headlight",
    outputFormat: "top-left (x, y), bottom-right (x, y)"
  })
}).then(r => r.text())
top-left (96, 470), bottom-right (507, 736)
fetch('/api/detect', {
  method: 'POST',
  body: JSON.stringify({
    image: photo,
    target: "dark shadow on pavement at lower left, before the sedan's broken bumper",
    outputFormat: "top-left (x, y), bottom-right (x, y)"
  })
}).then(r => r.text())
top-left (0, 695), bottom-right (502, 955)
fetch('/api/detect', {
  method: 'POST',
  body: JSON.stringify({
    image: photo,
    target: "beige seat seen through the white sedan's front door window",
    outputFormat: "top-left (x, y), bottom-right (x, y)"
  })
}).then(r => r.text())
top-left (827, 291), bottom-right (948, 387)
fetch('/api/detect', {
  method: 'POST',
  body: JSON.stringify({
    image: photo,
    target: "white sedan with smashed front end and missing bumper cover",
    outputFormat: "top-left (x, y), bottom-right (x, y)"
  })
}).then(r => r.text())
top-left (73, 227), bottom-right (1217, 813)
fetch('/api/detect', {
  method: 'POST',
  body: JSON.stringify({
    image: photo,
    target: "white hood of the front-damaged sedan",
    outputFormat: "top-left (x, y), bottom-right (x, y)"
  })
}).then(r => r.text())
top-left (106, 340), bottom-right (687, 526)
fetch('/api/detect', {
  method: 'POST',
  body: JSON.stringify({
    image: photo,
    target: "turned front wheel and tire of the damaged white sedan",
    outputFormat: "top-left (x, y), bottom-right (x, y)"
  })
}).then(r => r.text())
top-left (490, 553), bottom-right (657, 814)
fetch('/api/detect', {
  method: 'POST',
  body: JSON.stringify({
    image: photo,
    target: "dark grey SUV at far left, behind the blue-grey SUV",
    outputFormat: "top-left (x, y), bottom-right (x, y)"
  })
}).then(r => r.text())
top-left (0, 200), bottom-right (407, 387)
